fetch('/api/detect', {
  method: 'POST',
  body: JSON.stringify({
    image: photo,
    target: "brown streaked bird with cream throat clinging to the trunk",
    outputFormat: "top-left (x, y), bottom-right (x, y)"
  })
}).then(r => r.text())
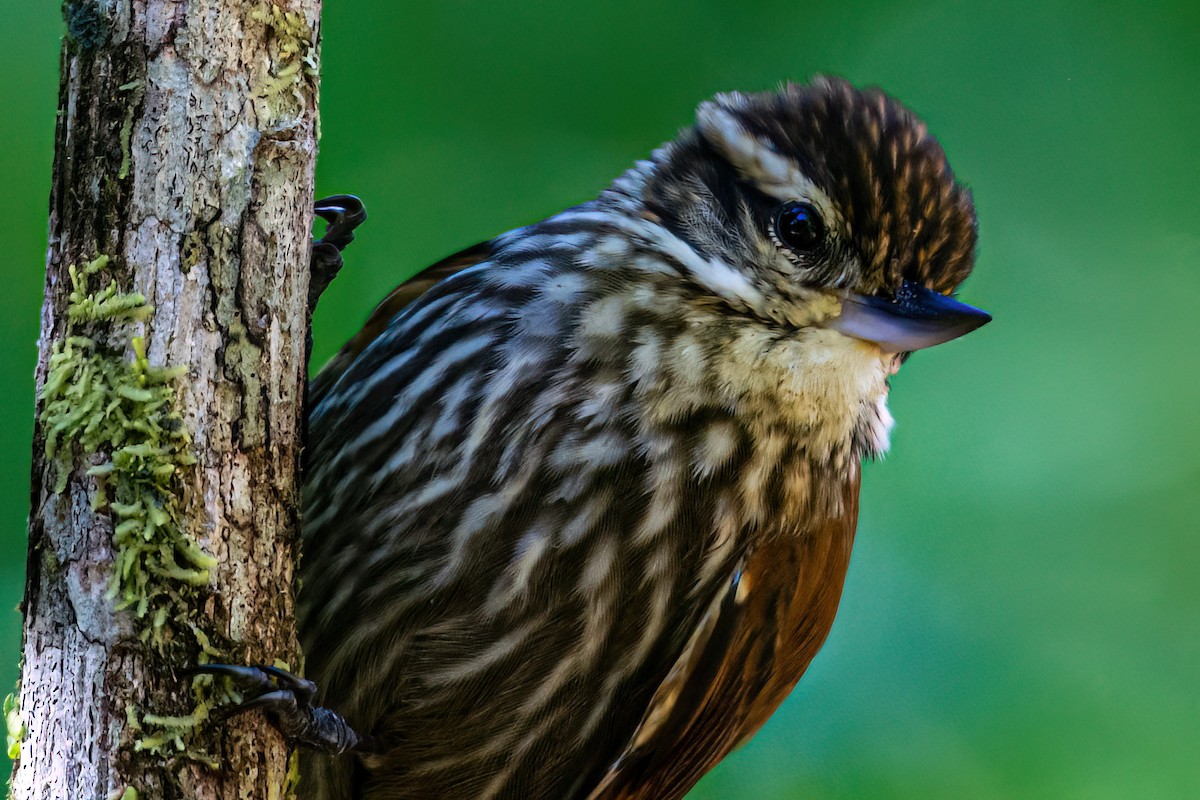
top-left (214, 77), bottom-right (990, 800)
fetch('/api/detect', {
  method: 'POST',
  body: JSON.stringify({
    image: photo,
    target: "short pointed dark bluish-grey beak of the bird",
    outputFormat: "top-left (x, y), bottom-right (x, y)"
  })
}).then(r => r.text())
top-left (826, 281), bottom-right (991, 353)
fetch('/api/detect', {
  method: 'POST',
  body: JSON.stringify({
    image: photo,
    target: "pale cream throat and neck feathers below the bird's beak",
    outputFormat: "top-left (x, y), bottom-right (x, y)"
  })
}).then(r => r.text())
top-left (643, 299), bottom-right (893, 529)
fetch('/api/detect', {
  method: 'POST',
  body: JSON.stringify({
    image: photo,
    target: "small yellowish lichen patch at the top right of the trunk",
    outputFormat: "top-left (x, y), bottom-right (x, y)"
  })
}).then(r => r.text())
top-left (250, 0), bottom-right (319, 127)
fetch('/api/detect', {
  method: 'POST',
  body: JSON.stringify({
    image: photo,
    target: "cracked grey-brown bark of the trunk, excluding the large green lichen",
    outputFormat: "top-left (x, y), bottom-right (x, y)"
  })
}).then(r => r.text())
top-left (13, 0), bottom-right (320, 800)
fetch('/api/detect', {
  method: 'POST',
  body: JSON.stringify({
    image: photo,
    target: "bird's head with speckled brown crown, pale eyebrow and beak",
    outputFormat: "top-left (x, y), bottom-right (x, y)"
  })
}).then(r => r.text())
top-left (646, 78), bottom-right (990, 354)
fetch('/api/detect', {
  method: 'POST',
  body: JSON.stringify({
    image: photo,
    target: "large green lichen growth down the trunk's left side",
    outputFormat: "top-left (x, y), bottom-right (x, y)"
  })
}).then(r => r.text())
top-left (38, 255), bottom-right (225, 765)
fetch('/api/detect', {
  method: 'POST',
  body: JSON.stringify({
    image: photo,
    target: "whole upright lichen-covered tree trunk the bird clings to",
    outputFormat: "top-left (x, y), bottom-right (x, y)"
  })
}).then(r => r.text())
top-left (10, 0), bottom-right (320, 800)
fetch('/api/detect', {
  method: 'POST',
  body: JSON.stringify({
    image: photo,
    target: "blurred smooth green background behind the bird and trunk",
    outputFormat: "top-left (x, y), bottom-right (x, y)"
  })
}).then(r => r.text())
top-left (0, 0), bottom-right (1200, 799)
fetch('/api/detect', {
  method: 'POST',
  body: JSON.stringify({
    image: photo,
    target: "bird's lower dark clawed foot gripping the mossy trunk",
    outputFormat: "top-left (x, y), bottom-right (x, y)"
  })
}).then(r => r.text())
top-left (190, 664), bottom-right (371, 756)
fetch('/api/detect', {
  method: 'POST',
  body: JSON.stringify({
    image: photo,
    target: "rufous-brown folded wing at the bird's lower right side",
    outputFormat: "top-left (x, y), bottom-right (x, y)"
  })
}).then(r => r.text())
top-left (588, 467), bottom-right (859, 800)
